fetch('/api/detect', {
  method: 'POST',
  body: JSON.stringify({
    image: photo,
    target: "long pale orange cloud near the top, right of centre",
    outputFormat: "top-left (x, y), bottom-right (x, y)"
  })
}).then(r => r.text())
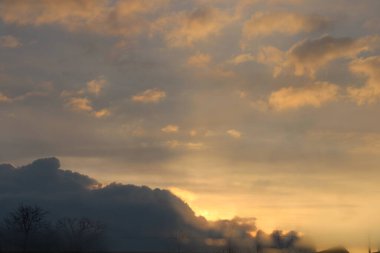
top-left (243, 12), bottom-right (329, 39)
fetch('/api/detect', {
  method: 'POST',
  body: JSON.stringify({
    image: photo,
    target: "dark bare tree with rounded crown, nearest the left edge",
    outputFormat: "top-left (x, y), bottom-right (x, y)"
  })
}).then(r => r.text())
top-left (4, 204), bottom-right (48, 251)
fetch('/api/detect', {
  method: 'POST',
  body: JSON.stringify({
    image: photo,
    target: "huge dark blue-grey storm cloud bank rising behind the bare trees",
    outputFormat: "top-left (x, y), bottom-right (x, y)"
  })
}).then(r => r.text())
top-left (0, 158), bottom-right (312, 250)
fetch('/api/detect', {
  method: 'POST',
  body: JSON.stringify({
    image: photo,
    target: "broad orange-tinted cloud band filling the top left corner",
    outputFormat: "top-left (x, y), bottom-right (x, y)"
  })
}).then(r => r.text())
top-left (0, 0), bottom-right (167, 36)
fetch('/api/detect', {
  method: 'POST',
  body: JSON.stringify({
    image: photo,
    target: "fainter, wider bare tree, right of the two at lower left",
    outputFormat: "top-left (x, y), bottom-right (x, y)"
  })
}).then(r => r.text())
top-left (56, 217), bottom-right (105, 252)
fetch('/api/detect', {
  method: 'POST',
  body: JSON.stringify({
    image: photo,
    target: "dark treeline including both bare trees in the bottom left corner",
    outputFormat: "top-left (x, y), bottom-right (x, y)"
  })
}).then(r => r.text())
top-left (0, 204), bottom-right (106, 252)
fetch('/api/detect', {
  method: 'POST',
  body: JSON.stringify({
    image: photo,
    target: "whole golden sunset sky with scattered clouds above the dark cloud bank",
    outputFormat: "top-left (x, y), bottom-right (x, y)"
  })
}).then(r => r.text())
top-left (0, 0), bottom-right (380, 252)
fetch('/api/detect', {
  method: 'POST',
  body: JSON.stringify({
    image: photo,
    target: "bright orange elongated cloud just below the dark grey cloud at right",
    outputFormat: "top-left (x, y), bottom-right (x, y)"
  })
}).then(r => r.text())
top-left (268, 82), bottom-right (339, 111)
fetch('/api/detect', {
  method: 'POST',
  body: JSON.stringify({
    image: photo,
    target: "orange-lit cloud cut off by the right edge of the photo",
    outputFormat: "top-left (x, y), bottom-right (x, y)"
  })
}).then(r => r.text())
top-left (347, 56), bottom-right (380, 105)
